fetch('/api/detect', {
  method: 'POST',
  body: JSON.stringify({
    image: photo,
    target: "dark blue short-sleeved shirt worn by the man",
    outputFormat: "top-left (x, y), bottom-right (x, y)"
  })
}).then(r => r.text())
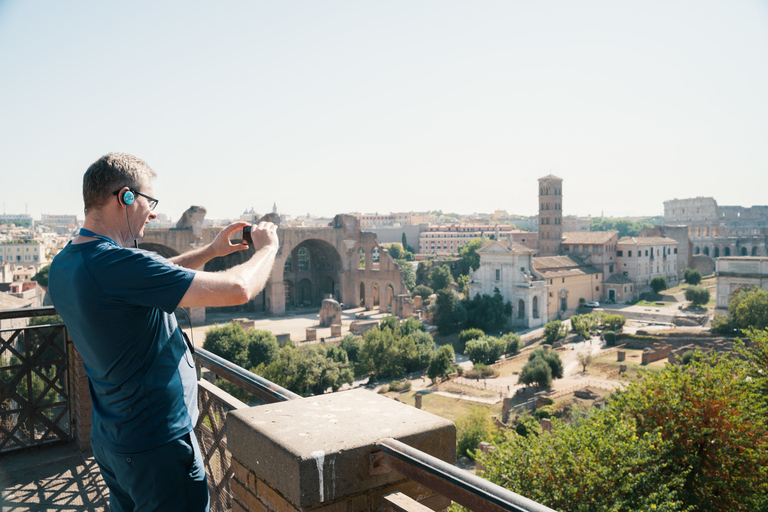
top-left (48, 240), bottom-right (198, 453)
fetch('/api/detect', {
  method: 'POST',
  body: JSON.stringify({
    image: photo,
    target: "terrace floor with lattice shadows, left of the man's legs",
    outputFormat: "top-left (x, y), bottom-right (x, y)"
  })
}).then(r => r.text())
top-left (0, 443), bottom-right (109, 512)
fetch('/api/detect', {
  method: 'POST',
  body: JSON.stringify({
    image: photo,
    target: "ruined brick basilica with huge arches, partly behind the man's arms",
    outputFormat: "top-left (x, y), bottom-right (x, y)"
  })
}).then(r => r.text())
top-left (139, 206), bottom-right (412, 324)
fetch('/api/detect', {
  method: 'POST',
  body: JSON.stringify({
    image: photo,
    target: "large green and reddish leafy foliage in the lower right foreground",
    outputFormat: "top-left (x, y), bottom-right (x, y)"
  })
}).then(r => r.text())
top-left (480, 344), bottom-right (768, 512)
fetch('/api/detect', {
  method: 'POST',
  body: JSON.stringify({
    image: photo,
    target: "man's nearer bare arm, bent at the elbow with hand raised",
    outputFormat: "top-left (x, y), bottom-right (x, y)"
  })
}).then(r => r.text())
top-left (179, 222), bottom-right (279, 307)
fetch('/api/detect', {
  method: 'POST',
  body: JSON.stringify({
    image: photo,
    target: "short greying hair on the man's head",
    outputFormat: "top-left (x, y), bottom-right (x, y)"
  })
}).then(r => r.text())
top-left (83, 153), bottom-right (157, 214)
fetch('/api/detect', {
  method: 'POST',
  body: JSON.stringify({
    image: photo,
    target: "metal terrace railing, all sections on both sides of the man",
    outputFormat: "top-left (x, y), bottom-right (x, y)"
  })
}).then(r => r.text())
top-left (0, 307), bottom-right (551, 512)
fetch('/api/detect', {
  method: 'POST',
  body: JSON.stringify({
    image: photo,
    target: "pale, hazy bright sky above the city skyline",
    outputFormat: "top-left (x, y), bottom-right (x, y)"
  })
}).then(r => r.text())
top-left (0, 0), bottom-right (768, 220)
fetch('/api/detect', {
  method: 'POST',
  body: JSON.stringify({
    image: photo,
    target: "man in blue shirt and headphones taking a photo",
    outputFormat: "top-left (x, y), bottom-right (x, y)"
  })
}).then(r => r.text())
top-left (49, 153), bottom-right (278, 512)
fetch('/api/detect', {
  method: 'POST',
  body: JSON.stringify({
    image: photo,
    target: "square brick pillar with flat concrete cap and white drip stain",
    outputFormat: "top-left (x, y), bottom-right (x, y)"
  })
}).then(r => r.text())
top-left (227, 389), bottom-right (456, 512)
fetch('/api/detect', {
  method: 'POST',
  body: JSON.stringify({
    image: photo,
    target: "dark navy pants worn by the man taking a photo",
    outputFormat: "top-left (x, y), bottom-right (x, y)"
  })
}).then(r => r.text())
top-left (91, 432), bottom-right (209, 512)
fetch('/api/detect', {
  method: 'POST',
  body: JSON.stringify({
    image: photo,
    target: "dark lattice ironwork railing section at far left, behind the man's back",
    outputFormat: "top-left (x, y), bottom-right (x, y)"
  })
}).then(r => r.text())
top-left (0, 308), bottom-right (72, 452)
